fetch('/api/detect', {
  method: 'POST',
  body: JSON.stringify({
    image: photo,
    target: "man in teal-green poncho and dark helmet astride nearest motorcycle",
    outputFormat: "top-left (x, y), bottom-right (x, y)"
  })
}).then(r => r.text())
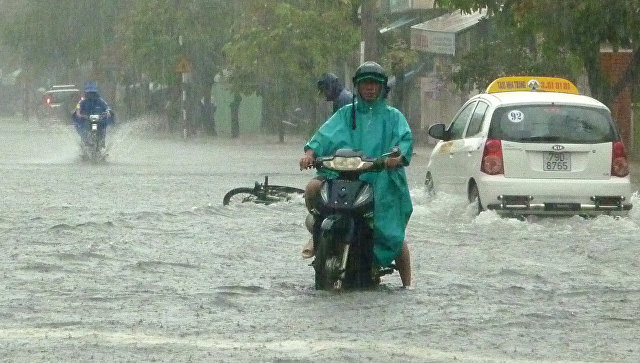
top-left (300, 61), bottom-right (413, 287)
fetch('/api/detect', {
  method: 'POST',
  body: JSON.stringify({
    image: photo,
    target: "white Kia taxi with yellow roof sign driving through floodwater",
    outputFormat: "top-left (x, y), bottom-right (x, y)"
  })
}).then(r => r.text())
top-left (425, 77), bottom-right (632, 216)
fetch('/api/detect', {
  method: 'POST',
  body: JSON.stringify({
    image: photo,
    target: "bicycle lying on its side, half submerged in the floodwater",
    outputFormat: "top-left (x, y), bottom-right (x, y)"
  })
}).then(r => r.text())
top-left (222, 176), bottom-right (304, 205)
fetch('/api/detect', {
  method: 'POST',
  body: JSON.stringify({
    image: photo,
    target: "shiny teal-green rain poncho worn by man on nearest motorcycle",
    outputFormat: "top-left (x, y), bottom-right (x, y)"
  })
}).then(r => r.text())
top-left (304, 97), bottom-right (413, 266)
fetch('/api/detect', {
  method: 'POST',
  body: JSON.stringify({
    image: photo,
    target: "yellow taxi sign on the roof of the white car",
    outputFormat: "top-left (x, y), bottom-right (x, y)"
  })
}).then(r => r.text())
top-left (486, 76), bottom-right (579, 95)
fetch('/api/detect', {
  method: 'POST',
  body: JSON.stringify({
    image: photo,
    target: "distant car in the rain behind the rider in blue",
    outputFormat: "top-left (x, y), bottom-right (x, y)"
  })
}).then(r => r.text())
top-left (37, 85), bottom-right (82, 123)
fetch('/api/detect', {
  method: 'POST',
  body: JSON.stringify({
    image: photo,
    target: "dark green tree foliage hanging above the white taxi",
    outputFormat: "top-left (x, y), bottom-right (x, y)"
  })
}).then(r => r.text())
top-left (437, 0), bottom-right (640, 100)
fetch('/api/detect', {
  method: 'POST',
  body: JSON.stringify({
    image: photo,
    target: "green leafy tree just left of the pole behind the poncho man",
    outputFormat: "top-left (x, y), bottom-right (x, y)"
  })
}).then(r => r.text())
top-left (224, 0), bottom-right (360, 136)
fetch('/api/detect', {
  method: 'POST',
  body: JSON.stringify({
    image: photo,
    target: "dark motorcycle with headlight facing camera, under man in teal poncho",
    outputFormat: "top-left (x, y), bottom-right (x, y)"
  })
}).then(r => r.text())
top-left (305, 148), bottom-right (399, 290)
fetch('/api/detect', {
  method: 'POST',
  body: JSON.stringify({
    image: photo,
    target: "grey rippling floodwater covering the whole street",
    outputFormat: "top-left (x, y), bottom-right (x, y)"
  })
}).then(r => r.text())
top-left (0, 119), bottom-right (640, 362)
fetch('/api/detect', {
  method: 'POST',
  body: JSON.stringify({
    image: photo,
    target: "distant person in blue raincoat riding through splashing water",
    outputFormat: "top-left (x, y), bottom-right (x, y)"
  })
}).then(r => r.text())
top-left (72, 81), bottom-right (115, 148)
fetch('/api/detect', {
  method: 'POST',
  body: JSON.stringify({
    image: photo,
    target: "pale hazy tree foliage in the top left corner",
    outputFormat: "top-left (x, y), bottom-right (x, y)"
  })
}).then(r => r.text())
top-left (0, 0), bottom-right (124, 79)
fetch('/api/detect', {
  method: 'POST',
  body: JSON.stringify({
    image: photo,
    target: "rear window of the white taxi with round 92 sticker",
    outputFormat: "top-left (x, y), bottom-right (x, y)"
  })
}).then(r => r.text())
top-left (489, 105), bottom-right (617, 144)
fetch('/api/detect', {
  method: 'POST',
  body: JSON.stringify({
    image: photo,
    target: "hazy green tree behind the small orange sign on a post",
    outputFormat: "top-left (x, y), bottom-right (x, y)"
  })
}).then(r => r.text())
top-left (119, 0), bottom-right (234, 133)
